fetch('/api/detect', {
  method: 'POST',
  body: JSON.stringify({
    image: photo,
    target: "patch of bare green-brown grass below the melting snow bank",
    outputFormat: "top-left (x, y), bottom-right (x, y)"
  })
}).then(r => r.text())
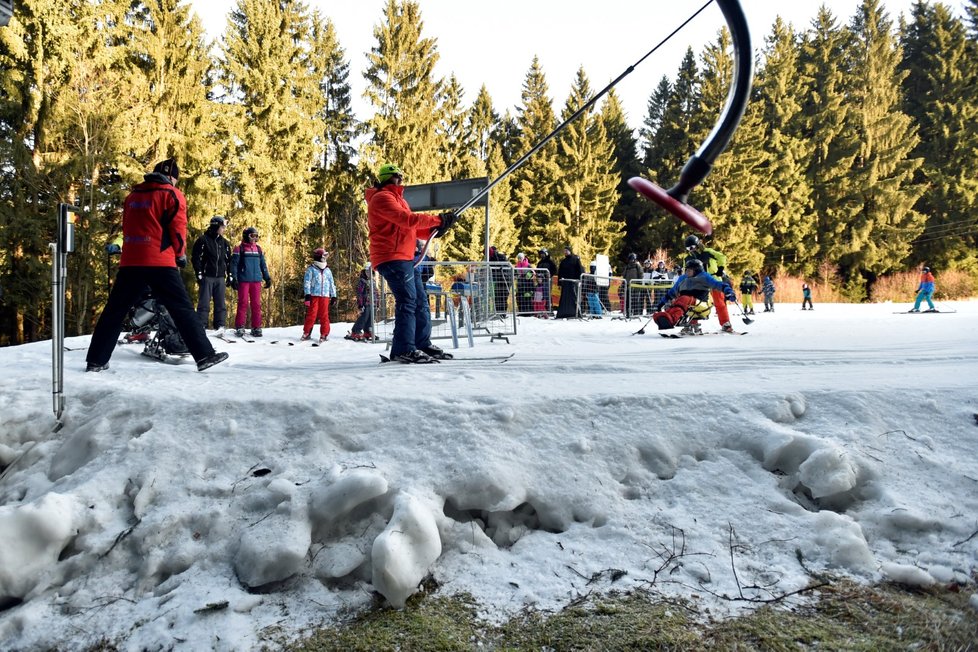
top-left (287, 581), bottom-right (978, 652)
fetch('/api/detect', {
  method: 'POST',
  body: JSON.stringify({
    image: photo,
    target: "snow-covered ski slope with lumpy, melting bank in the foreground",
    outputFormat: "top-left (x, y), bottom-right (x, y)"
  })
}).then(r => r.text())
top-left (0, 302), bottom-right (978, 650)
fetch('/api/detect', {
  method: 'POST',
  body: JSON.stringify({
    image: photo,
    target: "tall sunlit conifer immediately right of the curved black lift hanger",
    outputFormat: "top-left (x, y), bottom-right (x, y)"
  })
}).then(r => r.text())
top-left (755, 18), bottom-right (818, 275)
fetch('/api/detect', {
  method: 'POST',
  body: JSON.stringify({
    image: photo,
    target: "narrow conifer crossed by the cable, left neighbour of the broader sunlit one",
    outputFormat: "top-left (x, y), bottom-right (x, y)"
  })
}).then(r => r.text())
top-left (510, 57), bottom-right (561, 249)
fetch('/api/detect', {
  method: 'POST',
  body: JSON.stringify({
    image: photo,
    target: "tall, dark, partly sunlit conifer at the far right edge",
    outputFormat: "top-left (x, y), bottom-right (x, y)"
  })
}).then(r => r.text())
top-left (902, 2), bottom-right (978, 269)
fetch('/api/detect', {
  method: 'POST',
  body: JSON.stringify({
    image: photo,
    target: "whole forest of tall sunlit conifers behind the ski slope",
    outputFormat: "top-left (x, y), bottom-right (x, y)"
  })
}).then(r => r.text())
top-left (0, 0), bottom-right (978, 344)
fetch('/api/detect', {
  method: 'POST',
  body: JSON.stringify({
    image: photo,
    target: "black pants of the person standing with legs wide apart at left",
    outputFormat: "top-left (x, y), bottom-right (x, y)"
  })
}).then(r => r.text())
top-left (86, 267), bottom-right (214, 365)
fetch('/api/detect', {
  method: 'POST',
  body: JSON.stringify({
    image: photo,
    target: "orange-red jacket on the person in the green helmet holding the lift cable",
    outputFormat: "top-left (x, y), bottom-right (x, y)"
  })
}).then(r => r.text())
top-left (366, 184), bottom-right (441, 269)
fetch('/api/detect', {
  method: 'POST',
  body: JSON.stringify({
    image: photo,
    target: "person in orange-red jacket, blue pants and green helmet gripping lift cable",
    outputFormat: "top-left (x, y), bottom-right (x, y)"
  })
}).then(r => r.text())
top-left (366, 163), bottom-right (456, 363)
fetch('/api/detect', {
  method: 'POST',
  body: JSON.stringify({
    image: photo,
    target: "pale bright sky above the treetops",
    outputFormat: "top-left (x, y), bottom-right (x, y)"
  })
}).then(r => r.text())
top-left (191, 0), bottom-right (962, 127)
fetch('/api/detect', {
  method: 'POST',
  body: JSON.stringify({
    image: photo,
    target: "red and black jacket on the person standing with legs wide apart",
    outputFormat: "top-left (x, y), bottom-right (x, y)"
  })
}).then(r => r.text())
top-left (119, 173), bottom-right (187, 267)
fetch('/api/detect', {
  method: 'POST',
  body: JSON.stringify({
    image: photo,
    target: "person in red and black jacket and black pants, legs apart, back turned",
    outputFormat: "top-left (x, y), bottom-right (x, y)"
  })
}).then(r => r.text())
top-left (85, 158), bottom-right (228, 371)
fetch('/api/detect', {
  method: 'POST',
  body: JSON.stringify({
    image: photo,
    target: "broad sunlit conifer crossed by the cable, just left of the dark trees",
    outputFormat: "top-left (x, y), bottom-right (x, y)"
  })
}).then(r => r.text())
top-left (548, 68), bottom-right (621, 259)
